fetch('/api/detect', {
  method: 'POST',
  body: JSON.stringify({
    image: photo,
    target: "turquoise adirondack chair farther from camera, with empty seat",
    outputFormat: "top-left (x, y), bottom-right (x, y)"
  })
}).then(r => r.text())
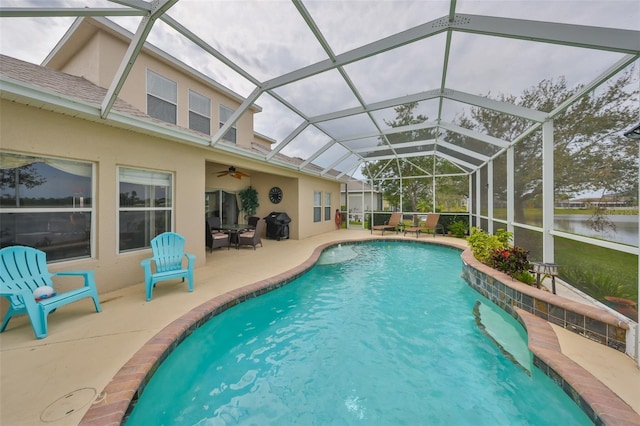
top-left (140, 232), bottom-right (196, 301)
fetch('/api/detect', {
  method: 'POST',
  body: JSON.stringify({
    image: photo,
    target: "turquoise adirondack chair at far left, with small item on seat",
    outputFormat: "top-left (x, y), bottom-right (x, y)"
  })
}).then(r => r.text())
top-left (0, 246), bottom-right (102, 339)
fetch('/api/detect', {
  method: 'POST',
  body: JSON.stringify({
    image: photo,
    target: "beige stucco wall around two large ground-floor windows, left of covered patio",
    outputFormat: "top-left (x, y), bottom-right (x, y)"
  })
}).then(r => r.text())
top-left (0, 100), bottom-right (205, 292)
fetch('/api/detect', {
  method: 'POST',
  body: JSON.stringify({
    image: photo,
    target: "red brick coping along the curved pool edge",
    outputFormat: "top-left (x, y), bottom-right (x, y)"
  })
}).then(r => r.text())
top-left (80, 239), bottom-right (640, 426)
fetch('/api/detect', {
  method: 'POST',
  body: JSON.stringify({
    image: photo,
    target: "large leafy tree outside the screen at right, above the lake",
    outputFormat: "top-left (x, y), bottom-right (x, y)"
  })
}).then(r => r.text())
top-left (458, 69), bottom-right (638, 222)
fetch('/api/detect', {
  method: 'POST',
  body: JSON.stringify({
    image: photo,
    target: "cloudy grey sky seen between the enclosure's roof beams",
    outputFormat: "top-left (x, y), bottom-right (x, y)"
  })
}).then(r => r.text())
top-left (0, 0), bottom-right (640, 178)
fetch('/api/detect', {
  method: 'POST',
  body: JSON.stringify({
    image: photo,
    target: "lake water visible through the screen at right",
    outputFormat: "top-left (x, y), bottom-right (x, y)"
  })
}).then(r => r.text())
top-left (555, 214), bottom-right (638, 247)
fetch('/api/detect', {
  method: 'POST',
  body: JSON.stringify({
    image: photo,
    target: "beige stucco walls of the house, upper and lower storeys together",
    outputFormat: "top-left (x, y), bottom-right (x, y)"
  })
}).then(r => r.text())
top-left (0, 20), bottom-right (340, 293)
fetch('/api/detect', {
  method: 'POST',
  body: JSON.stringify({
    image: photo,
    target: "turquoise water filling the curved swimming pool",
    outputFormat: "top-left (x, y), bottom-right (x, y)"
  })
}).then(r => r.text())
top-left (127, 242), bottom-right (591, 426)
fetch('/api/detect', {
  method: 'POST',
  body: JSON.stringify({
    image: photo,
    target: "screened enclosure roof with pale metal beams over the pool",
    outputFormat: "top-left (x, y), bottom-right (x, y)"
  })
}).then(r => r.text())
top-left (0, 0), bottom-right (640, 180)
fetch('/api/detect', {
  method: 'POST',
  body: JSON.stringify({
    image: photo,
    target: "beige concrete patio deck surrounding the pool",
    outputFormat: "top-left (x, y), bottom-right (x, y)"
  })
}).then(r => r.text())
top-left (0, 230), bottom-right (640, 426)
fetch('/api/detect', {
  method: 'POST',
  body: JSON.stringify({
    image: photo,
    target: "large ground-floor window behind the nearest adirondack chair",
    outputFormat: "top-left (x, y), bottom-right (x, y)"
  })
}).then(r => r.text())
top-left (0, 152), bottom-right (95, 261)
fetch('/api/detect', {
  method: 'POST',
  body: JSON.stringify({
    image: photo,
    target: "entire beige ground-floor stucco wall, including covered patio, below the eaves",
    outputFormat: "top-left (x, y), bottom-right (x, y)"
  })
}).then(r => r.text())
top-left (0, 100), bottom-right (340, 293)
